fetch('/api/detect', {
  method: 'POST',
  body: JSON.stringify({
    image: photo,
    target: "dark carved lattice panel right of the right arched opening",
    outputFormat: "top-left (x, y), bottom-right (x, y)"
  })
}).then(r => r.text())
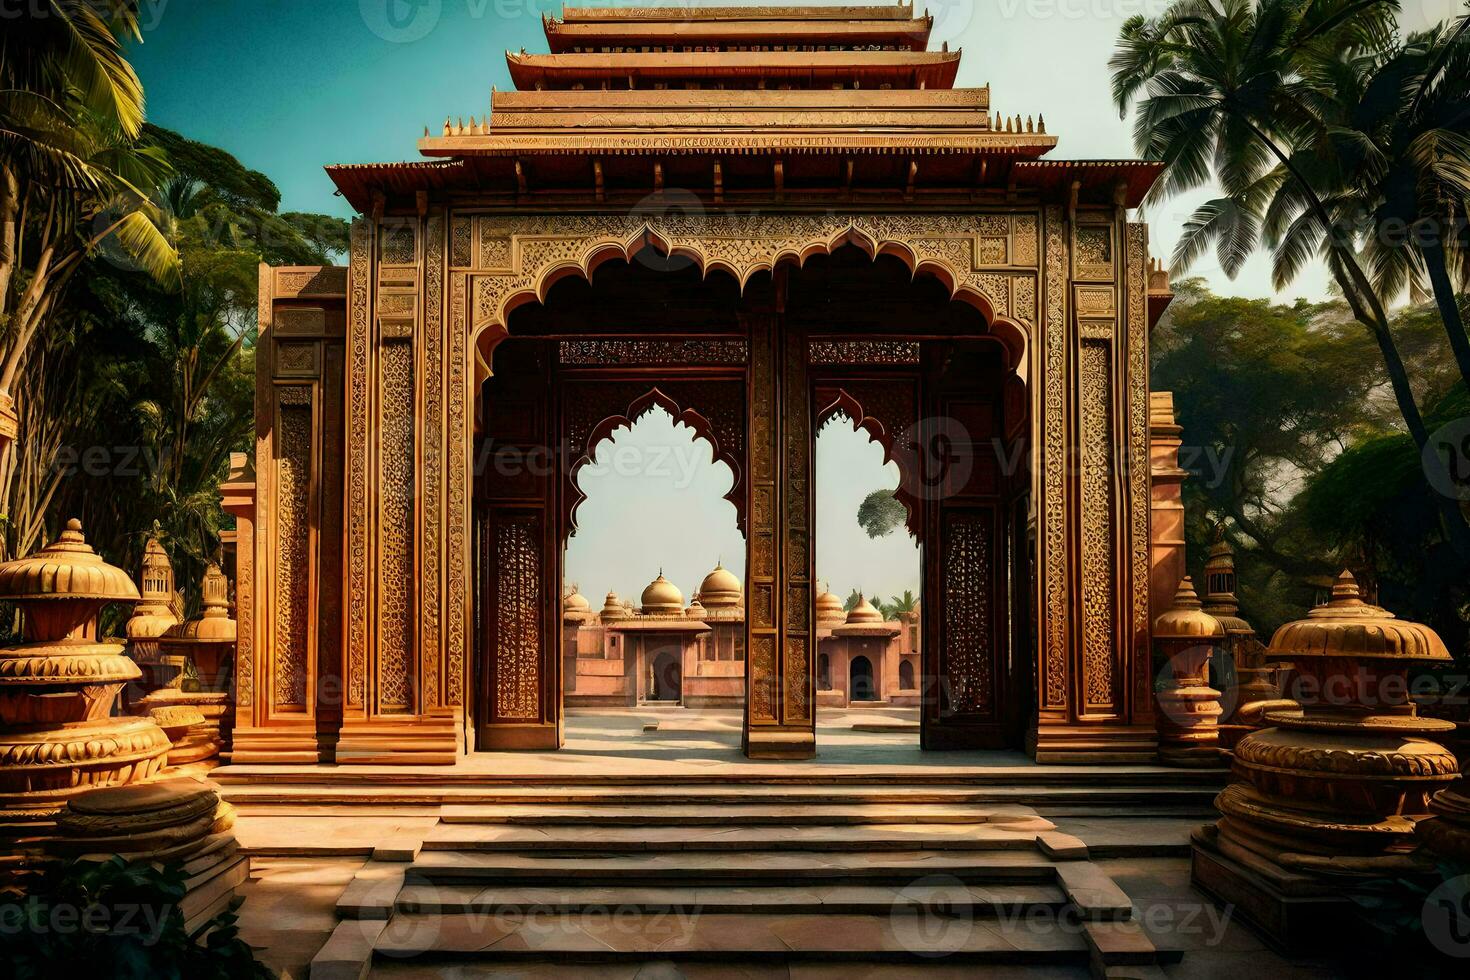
top-left (939, 510), bottom-right (997, 714)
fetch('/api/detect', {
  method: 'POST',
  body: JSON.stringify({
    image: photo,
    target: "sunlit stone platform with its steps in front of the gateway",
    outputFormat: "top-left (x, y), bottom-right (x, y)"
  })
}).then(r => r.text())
top-left (212, 710), bottom-right (1252, 977)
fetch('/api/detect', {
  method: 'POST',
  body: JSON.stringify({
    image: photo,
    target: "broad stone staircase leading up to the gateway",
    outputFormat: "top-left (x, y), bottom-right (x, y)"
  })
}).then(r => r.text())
top-left (252, 773), bottom-right (1216, 980)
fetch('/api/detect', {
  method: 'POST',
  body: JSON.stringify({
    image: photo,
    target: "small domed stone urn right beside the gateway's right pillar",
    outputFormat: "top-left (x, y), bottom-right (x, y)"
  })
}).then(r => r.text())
top-left (1154, 574), bottom-right (1225, 768)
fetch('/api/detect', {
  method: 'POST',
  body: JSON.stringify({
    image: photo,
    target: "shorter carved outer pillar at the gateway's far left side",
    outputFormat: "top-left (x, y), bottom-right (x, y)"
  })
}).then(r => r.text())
top-left (235, 266), bottom-right (347, 763)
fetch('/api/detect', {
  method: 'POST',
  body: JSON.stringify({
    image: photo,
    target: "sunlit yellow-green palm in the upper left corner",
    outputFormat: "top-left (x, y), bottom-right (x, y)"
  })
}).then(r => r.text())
top-left (0, 0), bottom-right (178, 461)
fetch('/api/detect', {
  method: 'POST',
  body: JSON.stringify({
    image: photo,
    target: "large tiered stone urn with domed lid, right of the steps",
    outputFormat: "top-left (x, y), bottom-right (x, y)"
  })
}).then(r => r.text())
top-left (1194, 573), bottom-right (1458, 948)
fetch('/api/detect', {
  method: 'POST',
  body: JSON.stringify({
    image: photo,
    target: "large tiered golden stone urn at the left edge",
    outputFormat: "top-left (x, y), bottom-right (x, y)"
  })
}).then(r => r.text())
top-left (0, 520), bottom-right (169, 837)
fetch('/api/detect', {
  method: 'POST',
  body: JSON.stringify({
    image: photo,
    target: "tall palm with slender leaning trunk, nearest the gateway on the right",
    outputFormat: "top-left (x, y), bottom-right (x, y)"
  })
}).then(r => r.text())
top-left (1108, 0), bottom-right (1470, 554)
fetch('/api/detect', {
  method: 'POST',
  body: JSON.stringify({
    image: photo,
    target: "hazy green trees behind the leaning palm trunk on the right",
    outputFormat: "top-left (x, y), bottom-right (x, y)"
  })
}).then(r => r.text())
top-left (1151, 281), bottom-right (1470, 651)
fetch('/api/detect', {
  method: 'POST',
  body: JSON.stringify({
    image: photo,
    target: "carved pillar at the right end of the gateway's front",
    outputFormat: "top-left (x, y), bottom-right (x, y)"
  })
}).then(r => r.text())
top-left (1035, 207), bottom-right (1157, 763)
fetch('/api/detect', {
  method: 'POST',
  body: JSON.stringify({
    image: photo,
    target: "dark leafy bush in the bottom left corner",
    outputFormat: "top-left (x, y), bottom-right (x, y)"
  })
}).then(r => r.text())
top-left (0, 857), bottom-right (272, 980)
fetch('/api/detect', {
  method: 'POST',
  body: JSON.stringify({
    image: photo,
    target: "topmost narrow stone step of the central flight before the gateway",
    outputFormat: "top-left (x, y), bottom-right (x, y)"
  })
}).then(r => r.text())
top-left (440, 802), bottom-right (1051, 830)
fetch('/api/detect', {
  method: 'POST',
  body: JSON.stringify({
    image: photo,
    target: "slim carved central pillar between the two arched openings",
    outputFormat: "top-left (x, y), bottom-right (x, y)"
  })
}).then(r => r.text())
top-left (744, 283), bottom-right (816, 758)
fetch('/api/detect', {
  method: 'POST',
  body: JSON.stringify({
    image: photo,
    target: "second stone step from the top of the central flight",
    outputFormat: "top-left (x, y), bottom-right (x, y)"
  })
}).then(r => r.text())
top-left (420, 820), bottom-right (1072, 854)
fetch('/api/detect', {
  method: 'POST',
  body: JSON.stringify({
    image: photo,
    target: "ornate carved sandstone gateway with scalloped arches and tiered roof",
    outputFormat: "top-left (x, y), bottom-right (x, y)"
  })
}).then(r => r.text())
top-left (241, 6), bottom-right (1183, 764)
